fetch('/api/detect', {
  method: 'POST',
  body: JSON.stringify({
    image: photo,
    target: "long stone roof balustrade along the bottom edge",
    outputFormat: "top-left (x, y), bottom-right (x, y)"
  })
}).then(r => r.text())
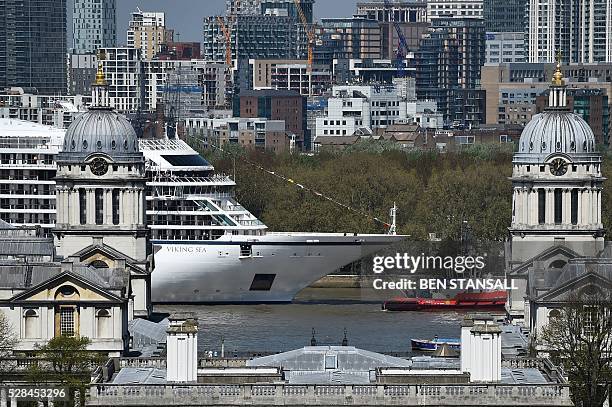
top-left (89, 383), bottom-right (573, 406)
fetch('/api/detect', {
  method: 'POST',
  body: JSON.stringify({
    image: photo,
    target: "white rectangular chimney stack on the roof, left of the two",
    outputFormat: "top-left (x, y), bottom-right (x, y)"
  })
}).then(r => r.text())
top-left (166, 312), bottom-right (198, 383)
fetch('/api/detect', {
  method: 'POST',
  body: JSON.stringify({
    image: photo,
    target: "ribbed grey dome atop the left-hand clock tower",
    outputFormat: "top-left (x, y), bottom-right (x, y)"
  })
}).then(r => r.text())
top-left (62, 109), bottom-right (138, 156)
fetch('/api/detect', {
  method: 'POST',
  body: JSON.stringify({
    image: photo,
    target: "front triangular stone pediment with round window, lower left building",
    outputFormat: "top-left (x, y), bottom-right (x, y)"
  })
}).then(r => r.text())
top-left (8, 272), bottom-right (124, 303)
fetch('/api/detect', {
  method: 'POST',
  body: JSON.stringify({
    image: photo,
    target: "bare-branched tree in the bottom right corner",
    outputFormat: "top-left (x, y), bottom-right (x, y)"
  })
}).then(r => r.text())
top-left (540, 297), bottom-right (612, 407)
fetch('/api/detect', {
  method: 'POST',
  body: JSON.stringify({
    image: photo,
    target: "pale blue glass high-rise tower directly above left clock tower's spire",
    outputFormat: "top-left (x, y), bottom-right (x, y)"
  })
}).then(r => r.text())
top-left (72, 0), bottom-right (117, 54)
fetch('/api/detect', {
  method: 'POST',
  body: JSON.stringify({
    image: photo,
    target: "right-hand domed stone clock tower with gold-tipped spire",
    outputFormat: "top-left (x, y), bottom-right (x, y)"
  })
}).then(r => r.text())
top-left (508, 57), bottom-right (604, 318)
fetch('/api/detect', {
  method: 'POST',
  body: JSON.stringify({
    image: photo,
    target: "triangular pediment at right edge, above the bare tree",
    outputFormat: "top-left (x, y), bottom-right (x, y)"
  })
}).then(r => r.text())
top-left (535, 273), bottom-right (612, 302)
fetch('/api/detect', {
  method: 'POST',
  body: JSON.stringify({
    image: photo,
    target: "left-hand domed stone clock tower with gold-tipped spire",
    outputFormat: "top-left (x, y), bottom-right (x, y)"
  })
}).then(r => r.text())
top-left (54, 63), bottom-right (149, 264)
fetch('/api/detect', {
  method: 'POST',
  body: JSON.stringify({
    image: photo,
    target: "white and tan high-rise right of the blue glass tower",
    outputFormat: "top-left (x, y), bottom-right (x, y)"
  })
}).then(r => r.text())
top-left (127, 9), bottom-right (174, 59)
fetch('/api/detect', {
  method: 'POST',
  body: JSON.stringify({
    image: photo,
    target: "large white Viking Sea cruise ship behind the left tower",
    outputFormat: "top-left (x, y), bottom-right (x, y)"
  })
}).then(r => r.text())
top-left (0, 119), bottom-right (403, 303)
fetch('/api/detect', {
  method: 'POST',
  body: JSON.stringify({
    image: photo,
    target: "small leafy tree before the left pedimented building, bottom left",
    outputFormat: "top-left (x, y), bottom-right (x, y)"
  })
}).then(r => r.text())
top-left (28, 336), bottom-right (107, 406)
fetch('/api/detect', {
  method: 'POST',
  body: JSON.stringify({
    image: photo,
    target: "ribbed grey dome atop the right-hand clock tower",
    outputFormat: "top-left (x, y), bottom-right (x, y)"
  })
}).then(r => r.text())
top-left (518, 110), bottom-right (595, 156)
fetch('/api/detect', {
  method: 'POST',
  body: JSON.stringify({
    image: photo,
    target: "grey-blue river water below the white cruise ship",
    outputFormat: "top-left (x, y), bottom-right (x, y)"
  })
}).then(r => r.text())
top-left (155, 289), bottom-right (464, 354)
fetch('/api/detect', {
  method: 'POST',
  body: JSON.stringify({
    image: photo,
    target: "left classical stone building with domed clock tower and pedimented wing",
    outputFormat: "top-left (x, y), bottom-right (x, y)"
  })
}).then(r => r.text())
top-left (0, 69), bottom-right (153, 356)
